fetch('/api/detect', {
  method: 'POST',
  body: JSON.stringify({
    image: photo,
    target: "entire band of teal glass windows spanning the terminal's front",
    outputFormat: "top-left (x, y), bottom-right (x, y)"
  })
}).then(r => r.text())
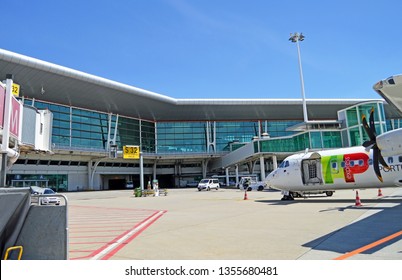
top-left (25, 100), bottom-right (402, 159)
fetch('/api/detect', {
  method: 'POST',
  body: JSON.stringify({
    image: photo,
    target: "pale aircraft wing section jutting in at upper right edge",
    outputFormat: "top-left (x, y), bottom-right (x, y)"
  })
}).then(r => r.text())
top-left (373, 74), bottom-right (402, 114)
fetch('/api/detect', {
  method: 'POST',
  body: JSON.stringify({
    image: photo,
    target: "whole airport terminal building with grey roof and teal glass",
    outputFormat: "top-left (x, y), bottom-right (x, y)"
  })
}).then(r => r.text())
top-left (0, 49), bottom-right (402, 191)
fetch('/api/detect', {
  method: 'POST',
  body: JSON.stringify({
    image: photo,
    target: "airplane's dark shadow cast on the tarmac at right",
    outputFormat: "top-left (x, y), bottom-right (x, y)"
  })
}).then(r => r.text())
top-left (256, 190), bottom-right (402, 259)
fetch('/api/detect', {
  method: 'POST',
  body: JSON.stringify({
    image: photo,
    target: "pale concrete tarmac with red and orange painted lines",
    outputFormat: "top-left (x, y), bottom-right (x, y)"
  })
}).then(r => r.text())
top-left (65, 188), bottom-right (402, 260)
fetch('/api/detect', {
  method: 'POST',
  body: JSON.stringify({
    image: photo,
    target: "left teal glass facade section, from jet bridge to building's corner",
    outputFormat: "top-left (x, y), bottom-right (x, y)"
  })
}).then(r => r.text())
top-left (25, 100), bottom-right (155, 152)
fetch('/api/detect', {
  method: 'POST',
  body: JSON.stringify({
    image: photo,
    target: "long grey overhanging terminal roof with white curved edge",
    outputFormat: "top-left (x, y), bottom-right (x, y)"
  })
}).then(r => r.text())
top-left (0, 49), bottom-right (398, 121)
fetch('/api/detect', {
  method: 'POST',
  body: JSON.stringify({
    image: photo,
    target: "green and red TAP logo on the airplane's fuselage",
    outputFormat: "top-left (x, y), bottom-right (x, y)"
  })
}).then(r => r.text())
top-left (321, 153), bottom-right (369, 184)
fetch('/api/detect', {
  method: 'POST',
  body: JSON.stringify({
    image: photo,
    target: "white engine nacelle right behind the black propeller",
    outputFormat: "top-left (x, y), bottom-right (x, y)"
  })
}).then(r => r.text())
top-left (376, 128), bottom-right (402, 157)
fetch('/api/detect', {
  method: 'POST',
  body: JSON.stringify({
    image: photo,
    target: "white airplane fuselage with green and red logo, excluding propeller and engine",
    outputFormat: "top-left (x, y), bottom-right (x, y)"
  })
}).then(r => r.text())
top-left (266, 147), bottom-right (402, 192)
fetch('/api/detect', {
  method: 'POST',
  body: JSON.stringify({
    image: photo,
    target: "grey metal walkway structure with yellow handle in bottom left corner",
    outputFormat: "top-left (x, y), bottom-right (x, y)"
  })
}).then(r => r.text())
top-left (0, 188), bottom-right (68, 260)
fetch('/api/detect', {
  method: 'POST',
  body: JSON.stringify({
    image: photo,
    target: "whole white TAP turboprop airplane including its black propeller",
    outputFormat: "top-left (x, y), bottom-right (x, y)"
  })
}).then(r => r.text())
top-left (265, 93), bottom-right (402, 200)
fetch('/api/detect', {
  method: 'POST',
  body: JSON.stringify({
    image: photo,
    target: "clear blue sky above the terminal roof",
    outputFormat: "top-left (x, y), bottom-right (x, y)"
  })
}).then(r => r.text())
top-left (0, 0), bottom-right (402, 99)
